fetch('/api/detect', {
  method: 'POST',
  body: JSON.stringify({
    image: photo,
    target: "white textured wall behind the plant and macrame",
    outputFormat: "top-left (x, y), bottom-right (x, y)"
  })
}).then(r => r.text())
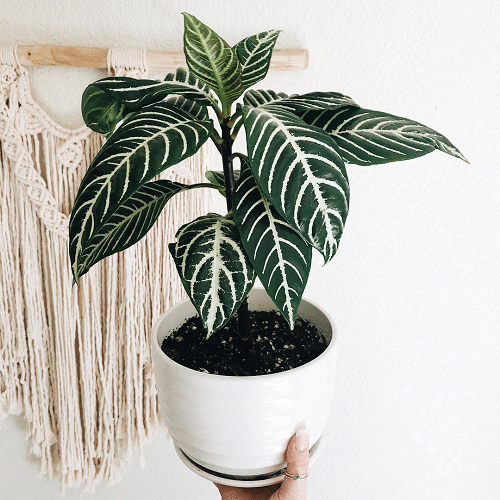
top-left (0, 0), bottom-right (500, 500)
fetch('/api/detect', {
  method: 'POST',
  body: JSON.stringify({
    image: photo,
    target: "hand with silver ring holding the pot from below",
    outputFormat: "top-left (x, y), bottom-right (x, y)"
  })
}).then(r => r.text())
top-left (214, 429), bottom-right (309, 500)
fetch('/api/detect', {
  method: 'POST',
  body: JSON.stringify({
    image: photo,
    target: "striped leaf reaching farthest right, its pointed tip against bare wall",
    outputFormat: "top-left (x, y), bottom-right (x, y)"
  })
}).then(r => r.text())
top-left (302, 107), bottom-right (467, 165)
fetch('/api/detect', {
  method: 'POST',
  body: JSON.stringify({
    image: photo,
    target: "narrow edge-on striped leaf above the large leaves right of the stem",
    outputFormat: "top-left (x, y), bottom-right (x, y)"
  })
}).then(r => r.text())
top-left (243, 90), bottom-right (357, 114)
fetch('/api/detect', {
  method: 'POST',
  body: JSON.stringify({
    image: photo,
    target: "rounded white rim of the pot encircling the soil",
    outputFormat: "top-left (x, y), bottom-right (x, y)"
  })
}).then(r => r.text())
top-left (152, 287), bottom-right (337, 383)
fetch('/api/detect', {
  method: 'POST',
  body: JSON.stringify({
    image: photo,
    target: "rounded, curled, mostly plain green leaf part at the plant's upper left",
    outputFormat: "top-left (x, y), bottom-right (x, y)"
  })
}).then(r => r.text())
top-left (82, 85), bottom-right (126, 135)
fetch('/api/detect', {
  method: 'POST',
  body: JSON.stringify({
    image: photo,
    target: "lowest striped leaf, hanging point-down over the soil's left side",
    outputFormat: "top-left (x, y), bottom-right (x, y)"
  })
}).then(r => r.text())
top-left (169, 214), bottom-right (255, 338)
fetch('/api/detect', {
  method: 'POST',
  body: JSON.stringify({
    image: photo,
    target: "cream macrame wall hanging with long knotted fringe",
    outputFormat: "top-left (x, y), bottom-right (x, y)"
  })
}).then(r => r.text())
top-left (0, 49), bottom-right (219, 490)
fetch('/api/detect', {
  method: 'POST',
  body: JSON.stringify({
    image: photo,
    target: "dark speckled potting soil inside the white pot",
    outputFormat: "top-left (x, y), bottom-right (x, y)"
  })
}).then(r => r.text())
top-left (161, 311), bottom-right (327, 375)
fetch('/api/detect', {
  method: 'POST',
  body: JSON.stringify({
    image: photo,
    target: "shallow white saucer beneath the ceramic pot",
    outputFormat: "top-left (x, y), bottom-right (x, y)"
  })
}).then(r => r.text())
top-left (174, 437), bottom-right (323, 488)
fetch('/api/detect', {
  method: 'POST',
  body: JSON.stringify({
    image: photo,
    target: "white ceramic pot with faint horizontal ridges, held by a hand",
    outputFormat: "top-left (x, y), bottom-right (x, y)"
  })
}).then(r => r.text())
top-left (152, 288), bottom-right (336, 486)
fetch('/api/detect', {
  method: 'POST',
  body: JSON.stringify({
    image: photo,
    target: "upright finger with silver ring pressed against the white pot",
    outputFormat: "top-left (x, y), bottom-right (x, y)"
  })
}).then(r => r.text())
top-left (279, 429), bottom-right (309, 500)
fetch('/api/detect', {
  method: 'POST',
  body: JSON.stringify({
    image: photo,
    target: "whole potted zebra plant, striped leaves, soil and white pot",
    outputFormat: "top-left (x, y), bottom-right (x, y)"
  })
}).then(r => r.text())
top-left (69, 13), bottom-right (466, 486)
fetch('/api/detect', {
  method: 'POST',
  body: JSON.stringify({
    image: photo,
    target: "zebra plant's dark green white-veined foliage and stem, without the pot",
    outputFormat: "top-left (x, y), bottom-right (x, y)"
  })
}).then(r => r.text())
top-left (69, 13), bottom-right (467, 338)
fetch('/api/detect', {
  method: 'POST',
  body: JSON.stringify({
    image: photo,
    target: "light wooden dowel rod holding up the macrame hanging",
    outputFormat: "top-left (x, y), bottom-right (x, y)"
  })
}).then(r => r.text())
top-left (17, 45), bottom-right (309, 71)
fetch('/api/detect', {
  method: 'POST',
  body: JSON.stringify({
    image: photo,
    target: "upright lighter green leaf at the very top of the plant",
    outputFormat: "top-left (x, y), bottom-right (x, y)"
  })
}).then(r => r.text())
top-left (183, 12), bottom-right (243, 115)
